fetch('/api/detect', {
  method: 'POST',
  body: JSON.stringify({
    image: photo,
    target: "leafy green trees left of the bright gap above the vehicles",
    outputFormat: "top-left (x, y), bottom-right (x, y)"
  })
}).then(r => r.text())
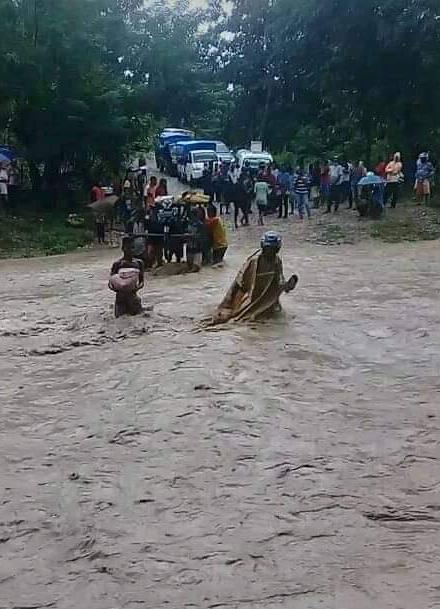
top-left (0, 0), bottom-right (214, 193)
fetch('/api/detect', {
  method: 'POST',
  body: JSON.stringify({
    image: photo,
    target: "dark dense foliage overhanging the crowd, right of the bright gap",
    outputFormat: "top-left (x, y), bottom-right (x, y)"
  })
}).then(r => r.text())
top-left (208, 0), bottom-right (440, 159)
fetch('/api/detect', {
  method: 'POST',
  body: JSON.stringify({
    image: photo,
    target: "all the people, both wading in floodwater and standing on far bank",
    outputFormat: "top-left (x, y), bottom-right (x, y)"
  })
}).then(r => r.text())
top-left (100, 152), bottom-right (435, 324)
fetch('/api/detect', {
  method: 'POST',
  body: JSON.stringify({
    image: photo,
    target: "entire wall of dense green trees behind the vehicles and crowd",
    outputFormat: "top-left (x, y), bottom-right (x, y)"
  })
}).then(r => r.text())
top-left (0, 0), bottom-right (440, 200)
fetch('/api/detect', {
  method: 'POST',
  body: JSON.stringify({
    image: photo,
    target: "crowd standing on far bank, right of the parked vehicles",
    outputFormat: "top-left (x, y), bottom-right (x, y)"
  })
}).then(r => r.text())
top-left (202, 152), bottom-right (435, 226)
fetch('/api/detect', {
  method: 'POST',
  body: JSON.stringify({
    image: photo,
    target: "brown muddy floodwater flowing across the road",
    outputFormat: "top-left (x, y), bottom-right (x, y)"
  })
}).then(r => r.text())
top-left (0, 207), bottom-right (440, 609)
